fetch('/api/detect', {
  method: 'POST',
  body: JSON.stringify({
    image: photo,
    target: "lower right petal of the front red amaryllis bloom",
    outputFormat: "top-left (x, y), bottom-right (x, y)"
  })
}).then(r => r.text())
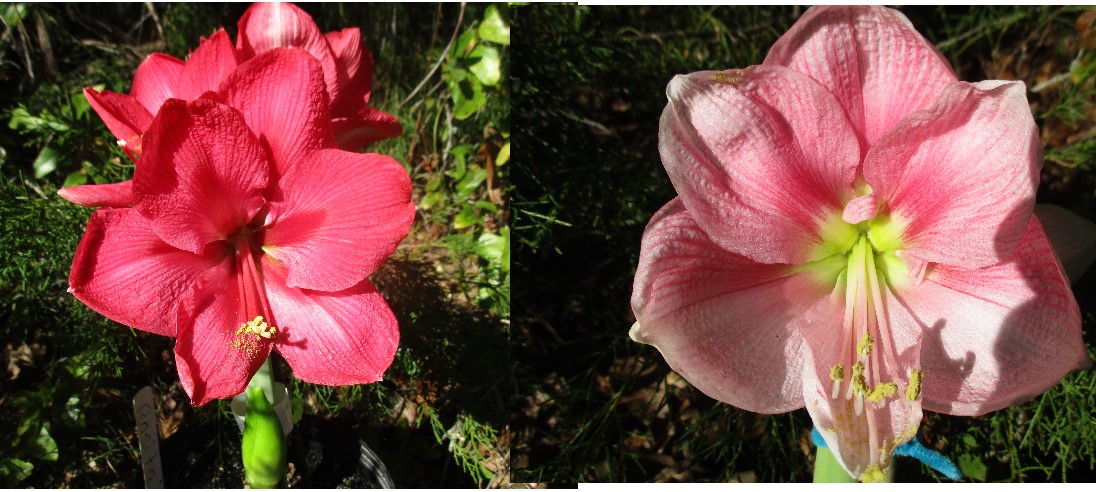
top-left (263, 260), bottom-right (400, 386)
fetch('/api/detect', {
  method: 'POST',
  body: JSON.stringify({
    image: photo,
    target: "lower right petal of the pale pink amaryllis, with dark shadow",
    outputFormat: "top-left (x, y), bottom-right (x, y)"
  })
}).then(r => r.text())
top-left (898, 216), bottom-right (1092, 415)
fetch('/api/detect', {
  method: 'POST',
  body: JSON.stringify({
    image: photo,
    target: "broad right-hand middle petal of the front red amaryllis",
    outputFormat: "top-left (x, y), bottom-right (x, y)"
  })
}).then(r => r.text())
top-left (264, 145), bottom-right (415, 291)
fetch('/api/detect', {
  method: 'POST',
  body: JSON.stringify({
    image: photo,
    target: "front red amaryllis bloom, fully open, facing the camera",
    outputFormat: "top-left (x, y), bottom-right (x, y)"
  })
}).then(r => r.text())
top-left (69, 95), bottom-right (414, 405)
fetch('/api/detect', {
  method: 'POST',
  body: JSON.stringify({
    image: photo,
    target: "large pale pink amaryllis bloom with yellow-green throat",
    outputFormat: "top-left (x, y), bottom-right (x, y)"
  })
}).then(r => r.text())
top-left (631, 7), bottom-right (1091, 481)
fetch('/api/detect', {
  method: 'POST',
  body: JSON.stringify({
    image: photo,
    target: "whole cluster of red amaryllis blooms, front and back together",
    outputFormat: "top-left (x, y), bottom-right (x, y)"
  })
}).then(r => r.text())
top-left (60, 4), bottom-right (415, 404)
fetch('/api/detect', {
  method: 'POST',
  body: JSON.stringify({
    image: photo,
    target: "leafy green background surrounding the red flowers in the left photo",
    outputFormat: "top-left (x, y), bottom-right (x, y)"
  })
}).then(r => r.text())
top-left (0, 3), bottom-right (510, 488)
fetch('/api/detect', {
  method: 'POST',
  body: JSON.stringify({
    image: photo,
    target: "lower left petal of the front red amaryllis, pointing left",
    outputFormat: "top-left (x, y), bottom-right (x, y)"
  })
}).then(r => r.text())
top-left (69, 208), bottom-right (220, 336)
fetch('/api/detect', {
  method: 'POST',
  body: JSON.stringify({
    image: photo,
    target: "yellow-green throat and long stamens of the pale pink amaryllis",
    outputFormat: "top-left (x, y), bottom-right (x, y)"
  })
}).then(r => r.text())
top-left (796, 206), bottom-right (923, 481)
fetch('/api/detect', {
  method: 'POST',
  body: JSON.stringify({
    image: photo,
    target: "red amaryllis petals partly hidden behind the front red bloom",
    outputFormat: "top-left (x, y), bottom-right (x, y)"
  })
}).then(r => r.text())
top-left (78, 3), bottom-right (402, 164)
